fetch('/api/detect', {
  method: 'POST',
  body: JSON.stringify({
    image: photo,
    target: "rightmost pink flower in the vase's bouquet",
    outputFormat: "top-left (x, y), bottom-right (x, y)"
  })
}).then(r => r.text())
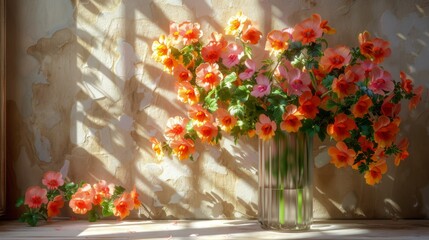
top-left (368, 67), bottom-right (395, 96)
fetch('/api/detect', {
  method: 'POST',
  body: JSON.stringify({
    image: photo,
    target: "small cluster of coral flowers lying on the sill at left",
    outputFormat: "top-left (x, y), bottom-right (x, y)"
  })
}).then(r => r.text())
top-left (16, 171), bottom-right (141, 226)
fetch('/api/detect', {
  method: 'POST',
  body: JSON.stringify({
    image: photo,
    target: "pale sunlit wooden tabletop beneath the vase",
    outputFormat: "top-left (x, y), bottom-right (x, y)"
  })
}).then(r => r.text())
top-left (0, 220), bottom-right (429, 240)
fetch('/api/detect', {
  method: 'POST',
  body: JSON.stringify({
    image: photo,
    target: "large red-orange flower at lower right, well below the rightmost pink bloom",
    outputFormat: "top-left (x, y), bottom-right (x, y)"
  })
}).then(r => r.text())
top-left (373, 116), bottom-right (399, 147)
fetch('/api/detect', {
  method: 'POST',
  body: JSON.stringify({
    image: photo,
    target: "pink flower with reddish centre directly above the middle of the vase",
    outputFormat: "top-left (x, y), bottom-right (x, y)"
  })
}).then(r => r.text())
top-left (283, 68), bottom-right (311, 96)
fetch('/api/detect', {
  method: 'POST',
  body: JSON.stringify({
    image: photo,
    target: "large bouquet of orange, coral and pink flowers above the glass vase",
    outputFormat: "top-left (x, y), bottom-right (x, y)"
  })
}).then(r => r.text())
top-left (151, 12), bottom-right (423, 185)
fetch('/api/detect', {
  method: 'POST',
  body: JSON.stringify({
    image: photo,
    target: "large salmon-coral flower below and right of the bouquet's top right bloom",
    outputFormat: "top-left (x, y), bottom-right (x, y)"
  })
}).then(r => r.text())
top-left (320, 46), bottom-right (351, 72)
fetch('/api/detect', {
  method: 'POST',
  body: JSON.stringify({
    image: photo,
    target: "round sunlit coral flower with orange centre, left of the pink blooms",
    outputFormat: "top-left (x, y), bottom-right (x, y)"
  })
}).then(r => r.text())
top-left (195, 63), bottom-right (223, 91)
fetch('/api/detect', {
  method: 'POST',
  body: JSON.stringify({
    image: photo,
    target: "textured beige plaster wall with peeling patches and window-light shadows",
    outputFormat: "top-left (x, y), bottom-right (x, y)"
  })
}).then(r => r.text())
top-left (6, 0), bottom-right (429, 219)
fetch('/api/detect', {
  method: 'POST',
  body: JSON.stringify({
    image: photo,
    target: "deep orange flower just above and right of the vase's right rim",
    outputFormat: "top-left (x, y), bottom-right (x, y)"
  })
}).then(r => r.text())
top-left (327, 113), bottom-right (357, 141)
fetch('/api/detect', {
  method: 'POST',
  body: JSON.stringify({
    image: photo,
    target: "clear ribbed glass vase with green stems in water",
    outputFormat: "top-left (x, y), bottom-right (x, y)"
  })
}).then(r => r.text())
top-left (258, 132), bottom-right (313, 231)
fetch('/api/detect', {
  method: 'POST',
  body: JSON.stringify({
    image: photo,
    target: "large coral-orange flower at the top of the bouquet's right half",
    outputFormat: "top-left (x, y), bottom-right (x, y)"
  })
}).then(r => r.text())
top-left (293, 14), bottom-right (323, 44)
